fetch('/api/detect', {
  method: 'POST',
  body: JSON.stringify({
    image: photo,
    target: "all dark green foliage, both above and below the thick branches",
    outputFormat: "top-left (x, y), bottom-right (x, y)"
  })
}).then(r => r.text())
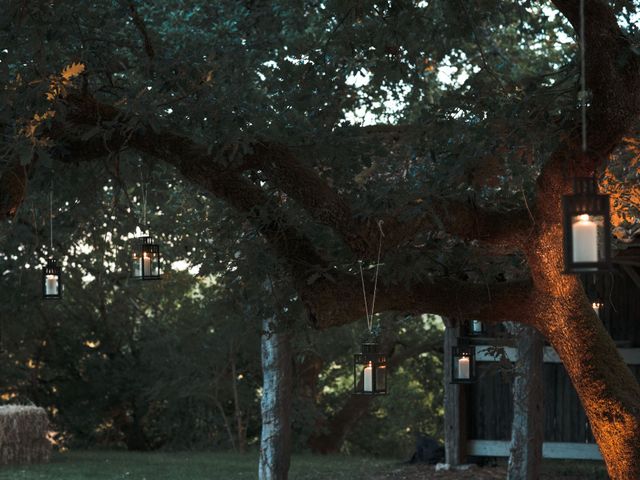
top-left (0, 0), bottom-right (638, 462)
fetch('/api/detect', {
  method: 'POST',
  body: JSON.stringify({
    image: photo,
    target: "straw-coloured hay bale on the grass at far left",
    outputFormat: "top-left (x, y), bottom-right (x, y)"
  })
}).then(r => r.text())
top-left (0, 405), bottom-right (51, 465)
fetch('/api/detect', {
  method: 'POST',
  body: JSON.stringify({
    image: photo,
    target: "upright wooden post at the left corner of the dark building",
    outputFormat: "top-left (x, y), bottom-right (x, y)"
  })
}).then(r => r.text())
top-left (443, 319), bottom-right (467, 465)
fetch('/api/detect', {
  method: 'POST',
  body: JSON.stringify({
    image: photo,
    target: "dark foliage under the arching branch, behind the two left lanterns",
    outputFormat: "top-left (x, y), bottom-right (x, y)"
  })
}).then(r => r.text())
top-left (0, 161), bottom-right (264, 449)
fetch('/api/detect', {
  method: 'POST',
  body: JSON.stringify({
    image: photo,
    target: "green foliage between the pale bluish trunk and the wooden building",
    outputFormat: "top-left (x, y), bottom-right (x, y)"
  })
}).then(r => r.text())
top-left (293, 315), bottom-right (444, 458)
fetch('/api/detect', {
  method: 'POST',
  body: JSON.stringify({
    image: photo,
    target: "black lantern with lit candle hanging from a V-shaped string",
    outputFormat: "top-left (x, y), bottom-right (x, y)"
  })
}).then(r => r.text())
top-left (353, 343), bottom-right (387, 395)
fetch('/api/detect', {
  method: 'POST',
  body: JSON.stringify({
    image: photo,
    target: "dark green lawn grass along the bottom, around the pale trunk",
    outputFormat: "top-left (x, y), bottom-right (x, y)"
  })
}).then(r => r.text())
top-left (0, 451), bottom-right (399, 480)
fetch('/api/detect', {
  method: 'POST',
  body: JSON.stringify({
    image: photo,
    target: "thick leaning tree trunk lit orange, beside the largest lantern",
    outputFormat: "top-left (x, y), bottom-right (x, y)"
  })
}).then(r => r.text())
top-left (523, 218), bottom-right (640, 480)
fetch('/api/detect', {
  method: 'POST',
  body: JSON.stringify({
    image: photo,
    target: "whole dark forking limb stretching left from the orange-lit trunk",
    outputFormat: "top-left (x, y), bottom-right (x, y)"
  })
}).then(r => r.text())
top-left (0, 94), bottom-right (529, 327)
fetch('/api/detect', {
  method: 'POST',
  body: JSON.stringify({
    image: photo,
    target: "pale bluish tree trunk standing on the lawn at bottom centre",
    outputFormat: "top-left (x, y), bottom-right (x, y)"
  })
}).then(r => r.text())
top-left (259, 316), bottom-right (292, 480)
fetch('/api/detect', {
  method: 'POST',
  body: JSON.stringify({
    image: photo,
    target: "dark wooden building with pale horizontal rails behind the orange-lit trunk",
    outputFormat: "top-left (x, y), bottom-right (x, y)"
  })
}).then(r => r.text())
top-left (445, 246), bottom-right (640, 464)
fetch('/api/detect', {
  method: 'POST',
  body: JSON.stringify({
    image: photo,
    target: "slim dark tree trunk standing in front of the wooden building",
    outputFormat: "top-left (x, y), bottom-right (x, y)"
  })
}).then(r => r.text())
top-left (507, 324), bottom-right (544, 480)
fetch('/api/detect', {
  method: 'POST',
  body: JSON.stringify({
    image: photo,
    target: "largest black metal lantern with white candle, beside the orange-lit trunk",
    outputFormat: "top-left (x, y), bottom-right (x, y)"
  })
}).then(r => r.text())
top-left (562, 177), bottom-right (611, 273)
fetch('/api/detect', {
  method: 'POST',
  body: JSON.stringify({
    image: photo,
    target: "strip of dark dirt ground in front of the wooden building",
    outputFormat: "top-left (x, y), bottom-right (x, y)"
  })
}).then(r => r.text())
top-left (373, 465), bottom-right (608, 480)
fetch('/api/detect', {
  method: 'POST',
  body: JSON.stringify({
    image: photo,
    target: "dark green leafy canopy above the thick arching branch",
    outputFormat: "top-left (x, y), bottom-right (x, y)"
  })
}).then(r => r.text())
top-left (0, 0), bottom-right (637, 283)
